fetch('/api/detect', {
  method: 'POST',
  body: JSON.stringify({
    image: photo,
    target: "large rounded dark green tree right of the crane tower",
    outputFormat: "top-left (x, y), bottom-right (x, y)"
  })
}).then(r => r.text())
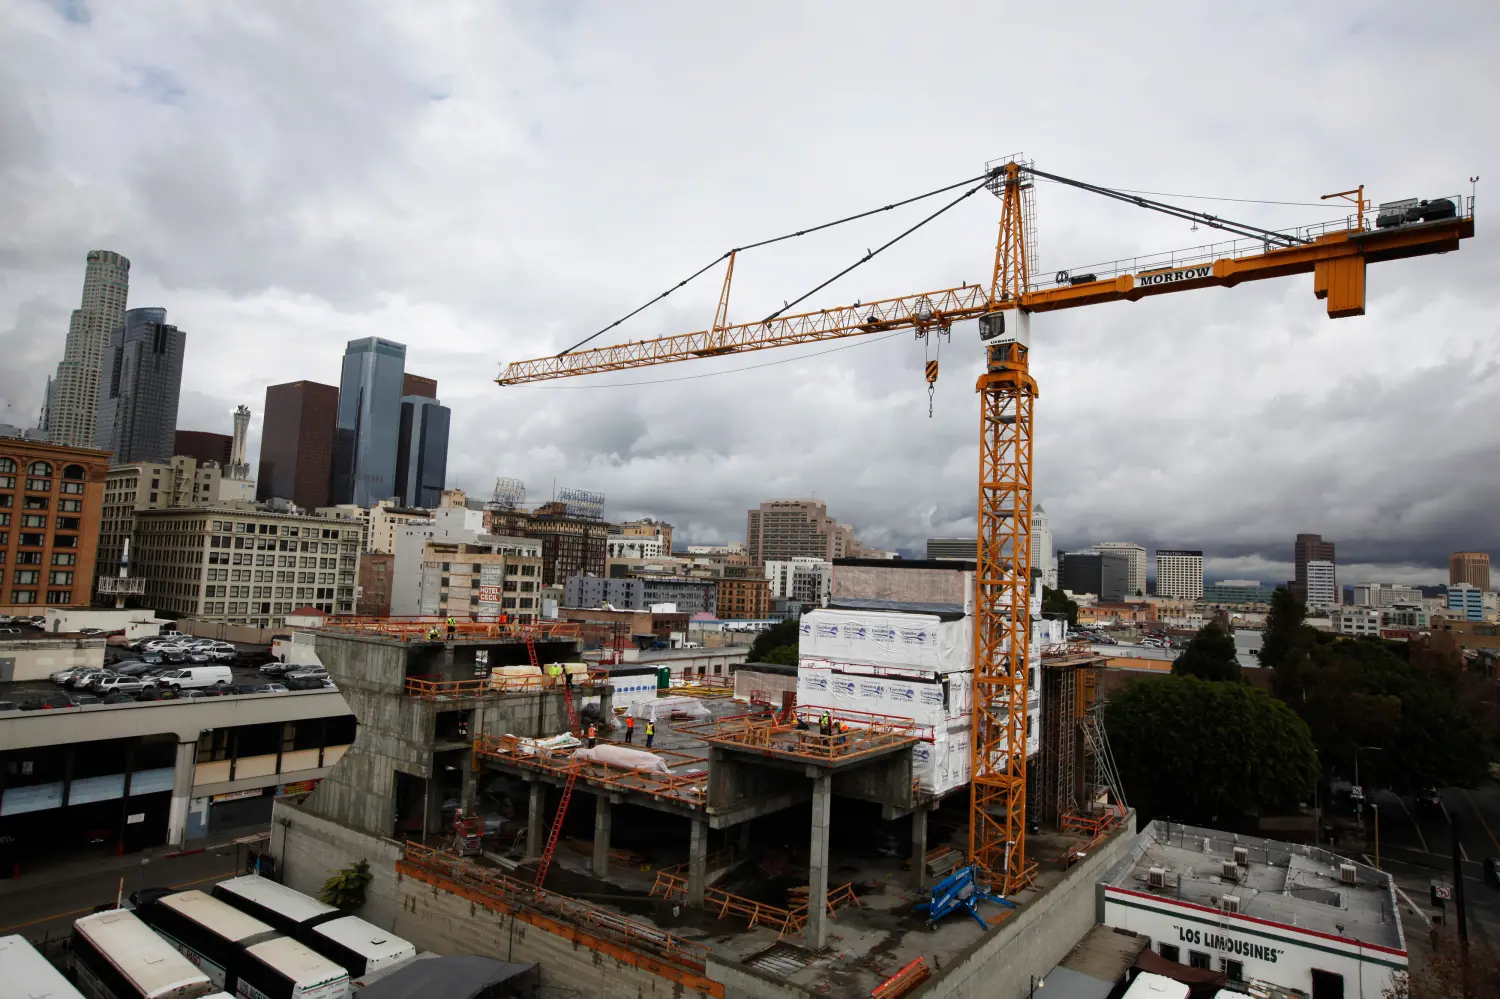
top-left (1104, 677), bottom-right (1319, 825)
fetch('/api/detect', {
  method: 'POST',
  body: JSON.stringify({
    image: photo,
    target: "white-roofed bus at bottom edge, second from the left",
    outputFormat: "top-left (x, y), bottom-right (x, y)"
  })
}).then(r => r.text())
top-left (72, 909), bottom-right (219, 999)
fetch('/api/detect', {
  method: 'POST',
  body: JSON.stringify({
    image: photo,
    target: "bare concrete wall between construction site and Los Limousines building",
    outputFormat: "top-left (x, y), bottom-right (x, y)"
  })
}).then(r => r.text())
top-left (912, 812), bottom-right (1136, 999)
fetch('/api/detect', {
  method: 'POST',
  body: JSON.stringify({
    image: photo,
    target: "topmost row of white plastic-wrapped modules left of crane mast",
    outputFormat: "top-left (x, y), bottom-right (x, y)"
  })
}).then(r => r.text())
top-left (798, 609), bottom-right (974, 672)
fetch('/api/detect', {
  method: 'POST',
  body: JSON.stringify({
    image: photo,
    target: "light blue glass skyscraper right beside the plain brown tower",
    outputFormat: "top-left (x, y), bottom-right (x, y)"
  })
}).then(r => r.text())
top-left (333, 336), bottom-right (407, 507)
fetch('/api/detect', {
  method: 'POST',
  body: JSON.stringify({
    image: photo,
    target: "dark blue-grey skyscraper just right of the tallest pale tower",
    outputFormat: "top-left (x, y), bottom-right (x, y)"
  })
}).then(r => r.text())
top-left (95, 309), bottom-right (188, 465)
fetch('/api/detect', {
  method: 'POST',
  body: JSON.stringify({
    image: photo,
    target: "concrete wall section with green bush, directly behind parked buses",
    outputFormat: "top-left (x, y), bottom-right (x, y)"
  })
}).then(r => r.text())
top-left (270, 798), bottom-right (405, 924)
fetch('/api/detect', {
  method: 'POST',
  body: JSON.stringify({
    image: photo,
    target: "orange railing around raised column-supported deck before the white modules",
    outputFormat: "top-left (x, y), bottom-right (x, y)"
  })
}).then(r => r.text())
top-left (675, 707), bottom-right (933, 764)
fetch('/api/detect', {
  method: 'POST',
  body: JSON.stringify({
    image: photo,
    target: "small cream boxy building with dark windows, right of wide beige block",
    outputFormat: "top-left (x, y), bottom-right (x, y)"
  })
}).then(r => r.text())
top-left (419, 534), bottom-right (542, 623)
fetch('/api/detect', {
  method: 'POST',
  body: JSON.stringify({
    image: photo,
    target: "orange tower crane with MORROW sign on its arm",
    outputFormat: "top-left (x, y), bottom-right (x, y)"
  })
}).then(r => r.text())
top-left (497, 156), bottom-right (1475, 894)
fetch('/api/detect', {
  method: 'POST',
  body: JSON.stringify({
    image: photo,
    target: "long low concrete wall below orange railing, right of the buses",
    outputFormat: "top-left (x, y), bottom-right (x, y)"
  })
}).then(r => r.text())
top-left (396, 878), bottom-right (699, 999)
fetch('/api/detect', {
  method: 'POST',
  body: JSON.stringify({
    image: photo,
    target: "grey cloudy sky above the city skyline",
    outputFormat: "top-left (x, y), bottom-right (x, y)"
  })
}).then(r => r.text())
top-left (0, 0), bottom-right (1500, 582)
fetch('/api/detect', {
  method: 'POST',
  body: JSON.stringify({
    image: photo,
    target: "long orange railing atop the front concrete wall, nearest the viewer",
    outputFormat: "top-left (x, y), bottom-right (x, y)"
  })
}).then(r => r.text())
top-left (402, 842), bottom-right (708, 972)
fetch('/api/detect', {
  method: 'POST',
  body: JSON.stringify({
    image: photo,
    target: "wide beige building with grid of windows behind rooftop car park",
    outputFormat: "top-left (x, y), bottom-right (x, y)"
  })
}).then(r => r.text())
top-left (131, 504), bottom-right (362, 627)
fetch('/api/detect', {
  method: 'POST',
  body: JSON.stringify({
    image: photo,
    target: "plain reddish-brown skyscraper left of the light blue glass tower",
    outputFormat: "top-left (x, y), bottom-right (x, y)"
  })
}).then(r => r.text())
top-left (255, 381), bottom-right (339, 510)
